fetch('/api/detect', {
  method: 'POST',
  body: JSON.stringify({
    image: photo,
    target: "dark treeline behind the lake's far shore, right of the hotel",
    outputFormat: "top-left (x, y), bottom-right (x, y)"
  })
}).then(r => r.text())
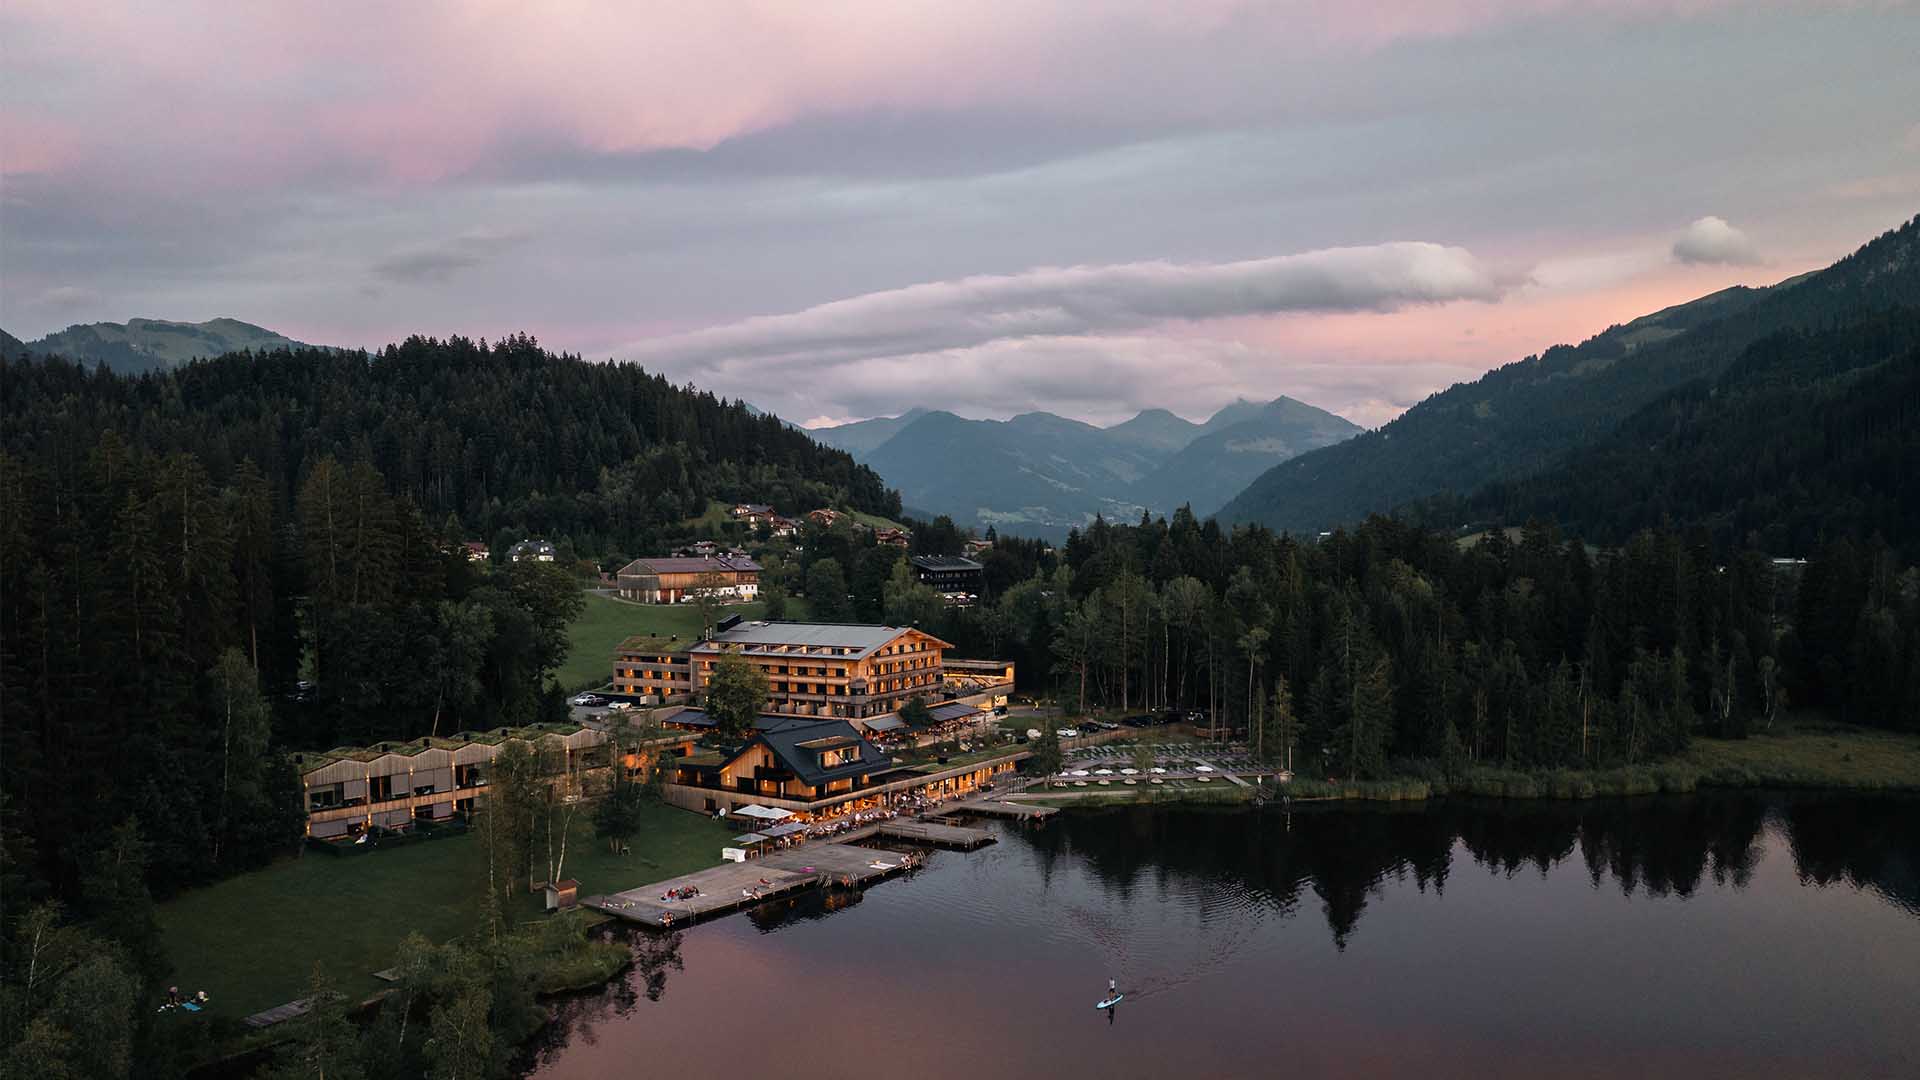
top-left (913, 511), bottom-right (1920, 778)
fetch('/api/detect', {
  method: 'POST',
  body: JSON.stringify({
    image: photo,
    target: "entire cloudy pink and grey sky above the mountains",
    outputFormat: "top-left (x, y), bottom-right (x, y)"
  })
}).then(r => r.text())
top-left (0, 0), bottom-right (1920, 427)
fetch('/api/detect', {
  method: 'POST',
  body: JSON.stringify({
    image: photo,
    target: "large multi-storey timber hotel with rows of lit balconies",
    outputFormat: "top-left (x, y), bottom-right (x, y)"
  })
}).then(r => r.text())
top-left (612, 623), bottom-right (952, 719)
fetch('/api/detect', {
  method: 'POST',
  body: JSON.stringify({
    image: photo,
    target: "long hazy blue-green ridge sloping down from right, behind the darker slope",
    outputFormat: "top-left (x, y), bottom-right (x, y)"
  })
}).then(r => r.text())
top-left (1219, 219), bottom-right (1920, 532)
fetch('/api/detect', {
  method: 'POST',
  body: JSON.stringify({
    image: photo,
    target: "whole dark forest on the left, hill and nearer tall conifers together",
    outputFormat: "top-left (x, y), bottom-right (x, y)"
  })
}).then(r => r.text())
top-left (0, 338), bottom-right (897, 903)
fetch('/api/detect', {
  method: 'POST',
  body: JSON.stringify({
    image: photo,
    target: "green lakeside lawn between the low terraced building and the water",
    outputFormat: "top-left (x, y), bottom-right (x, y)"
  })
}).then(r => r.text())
top-left (159, 805), bottom-right (733, 1019)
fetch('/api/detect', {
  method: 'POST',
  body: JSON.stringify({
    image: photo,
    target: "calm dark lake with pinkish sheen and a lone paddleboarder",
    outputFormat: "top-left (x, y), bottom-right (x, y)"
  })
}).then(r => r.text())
top-left (528, 794), bottom-right (1920, 1080)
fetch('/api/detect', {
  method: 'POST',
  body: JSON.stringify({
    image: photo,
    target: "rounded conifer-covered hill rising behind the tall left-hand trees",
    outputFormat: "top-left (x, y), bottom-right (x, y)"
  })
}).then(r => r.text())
top-left (0, 336), bottom-right (900, 552)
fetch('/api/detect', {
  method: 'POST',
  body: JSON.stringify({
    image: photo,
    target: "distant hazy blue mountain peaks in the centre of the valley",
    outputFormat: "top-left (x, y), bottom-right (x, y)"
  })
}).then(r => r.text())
top-left (810, 398), bottom-right (1361, 536)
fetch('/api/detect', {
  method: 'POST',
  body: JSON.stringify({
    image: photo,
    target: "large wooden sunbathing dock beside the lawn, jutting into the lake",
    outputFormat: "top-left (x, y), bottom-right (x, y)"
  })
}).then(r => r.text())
top-left (580, 840), bottom-right (910, 928)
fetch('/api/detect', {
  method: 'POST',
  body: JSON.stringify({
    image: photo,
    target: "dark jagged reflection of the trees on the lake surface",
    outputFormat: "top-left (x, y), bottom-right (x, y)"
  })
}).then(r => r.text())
top-left (1021, 794), bottom-right (1920, 945)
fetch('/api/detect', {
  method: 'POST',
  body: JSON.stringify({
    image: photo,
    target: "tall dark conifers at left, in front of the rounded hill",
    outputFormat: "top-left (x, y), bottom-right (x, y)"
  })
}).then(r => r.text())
top-left (0, 432), bottom-right (582, 897)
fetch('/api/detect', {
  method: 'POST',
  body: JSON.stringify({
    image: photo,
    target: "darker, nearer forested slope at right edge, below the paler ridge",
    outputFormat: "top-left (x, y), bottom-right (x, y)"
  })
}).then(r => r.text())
top-left (1451, 307), bottom-right (1920, 559)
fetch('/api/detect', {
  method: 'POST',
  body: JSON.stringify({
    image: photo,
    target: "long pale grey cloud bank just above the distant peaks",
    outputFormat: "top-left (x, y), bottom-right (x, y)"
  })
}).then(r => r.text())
top-left (616, 242), bottom-right (1501, 423)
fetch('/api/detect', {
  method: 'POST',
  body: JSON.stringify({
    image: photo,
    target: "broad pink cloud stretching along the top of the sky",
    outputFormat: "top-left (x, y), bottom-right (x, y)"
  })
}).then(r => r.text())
top-left (6, 0), bottom-right (1820, 183)
